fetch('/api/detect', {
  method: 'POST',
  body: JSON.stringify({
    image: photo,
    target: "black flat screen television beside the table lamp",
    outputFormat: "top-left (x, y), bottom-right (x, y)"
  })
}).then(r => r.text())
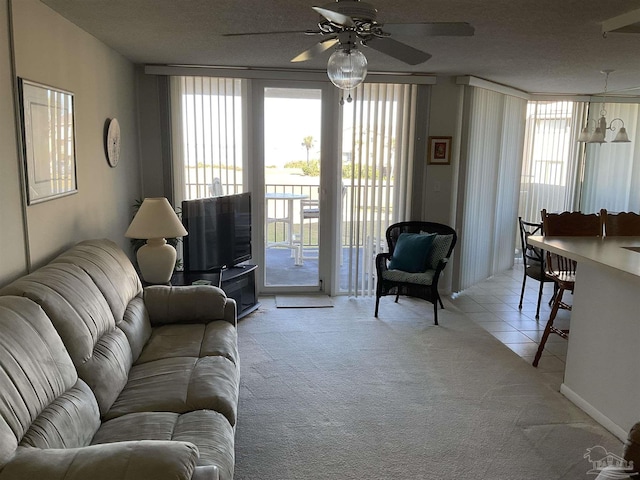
top-left (182, 192), bottom-right (251, 272)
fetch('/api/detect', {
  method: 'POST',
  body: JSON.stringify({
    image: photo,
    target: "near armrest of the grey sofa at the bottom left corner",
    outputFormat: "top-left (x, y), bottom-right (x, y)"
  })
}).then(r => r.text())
top-left (0, 440), bottom-right (204, 480)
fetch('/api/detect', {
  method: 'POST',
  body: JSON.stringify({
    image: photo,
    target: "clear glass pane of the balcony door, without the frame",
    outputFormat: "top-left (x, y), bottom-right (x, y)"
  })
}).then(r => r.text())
top-left (263, 87), bottom-right (322, 290)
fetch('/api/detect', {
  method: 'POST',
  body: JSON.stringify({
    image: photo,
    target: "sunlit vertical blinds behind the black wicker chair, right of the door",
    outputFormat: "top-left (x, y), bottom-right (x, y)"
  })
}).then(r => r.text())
top-left (342, 83), bottom-right (417, 296)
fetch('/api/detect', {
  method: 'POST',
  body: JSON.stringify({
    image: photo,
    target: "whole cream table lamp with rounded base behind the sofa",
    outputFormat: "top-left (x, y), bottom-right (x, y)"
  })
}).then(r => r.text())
top-left (124, 197), bottom-right (187, 283)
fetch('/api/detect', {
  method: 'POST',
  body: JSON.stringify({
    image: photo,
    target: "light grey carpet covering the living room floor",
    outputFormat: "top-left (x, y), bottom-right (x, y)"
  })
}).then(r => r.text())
top-left (235, 297), bottom-right (622, 480)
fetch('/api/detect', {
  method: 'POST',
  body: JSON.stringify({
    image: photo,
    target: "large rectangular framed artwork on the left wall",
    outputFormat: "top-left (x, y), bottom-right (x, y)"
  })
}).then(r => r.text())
top-left (19, 78), bottom-right (78, 205)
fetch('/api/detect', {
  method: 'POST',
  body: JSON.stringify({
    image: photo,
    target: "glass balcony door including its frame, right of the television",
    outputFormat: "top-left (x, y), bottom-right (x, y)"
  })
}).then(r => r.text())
top-left (252, 81), bottom-right (337, 293)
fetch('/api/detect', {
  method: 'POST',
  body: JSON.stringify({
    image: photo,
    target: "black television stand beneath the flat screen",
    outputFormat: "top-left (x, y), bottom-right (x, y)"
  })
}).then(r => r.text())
top-left (171, 265), bottom-right (260, 319)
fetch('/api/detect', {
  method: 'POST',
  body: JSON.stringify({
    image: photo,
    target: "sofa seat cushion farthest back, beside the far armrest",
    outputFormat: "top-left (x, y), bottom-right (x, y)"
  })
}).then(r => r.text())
top-left (137, 320), bottom-right (238, 366)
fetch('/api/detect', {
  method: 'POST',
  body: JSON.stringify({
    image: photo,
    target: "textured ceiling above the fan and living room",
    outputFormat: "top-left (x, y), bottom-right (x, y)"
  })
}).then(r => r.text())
top-left (41, 0), bottom-right (640, 95)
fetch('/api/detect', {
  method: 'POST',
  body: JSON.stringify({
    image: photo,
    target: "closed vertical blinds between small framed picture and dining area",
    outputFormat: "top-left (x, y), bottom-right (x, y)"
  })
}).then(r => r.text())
top-left (453, 86), bottom-right (527, 291)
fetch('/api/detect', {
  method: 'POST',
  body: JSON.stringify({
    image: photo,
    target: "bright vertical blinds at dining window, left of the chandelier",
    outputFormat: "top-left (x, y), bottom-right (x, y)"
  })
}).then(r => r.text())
top-left (518, 101), bottom-right (586, 222)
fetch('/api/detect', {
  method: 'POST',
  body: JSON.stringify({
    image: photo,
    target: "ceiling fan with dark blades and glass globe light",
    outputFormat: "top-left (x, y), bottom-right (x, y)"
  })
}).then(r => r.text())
top-left (225, 0), bottom-right (474, 90)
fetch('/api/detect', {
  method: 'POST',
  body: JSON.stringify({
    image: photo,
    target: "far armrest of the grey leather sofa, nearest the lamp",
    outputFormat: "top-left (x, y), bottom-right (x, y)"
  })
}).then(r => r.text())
top-left (144, 285), bottom-right (237, 327)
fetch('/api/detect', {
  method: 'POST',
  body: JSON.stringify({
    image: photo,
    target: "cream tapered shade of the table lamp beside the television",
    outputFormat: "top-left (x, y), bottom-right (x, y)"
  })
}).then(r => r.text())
top-left (124, 197), bottom-right (187, 239)
